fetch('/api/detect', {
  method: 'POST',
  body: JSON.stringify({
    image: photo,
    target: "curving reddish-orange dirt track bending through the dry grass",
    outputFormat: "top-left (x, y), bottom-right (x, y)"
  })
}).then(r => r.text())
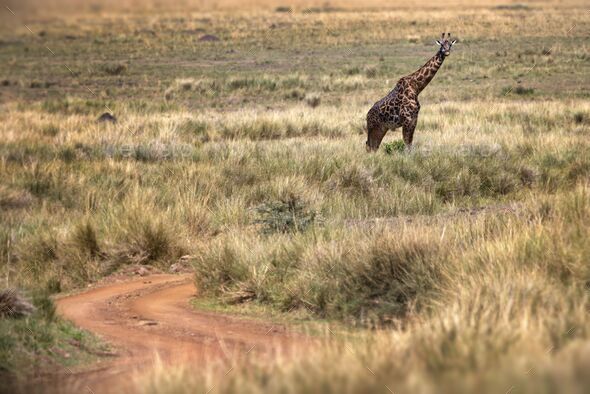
top-left (44, 275), bottom-right (303, 394)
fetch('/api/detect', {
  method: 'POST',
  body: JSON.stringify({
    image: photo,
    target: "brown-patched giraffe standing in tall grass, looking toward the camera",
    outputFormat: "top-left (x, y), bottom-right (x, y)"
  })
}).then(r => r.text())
top-left (367, 33), bottom-right (457, 152)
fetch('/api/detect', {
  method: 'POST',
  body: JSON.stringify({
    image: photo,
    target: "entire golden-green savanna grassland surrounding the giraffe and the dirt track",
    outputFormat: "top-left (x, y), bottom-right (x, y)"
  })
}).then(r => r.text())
top-left (0, 0), bottom-right (590, 393)
